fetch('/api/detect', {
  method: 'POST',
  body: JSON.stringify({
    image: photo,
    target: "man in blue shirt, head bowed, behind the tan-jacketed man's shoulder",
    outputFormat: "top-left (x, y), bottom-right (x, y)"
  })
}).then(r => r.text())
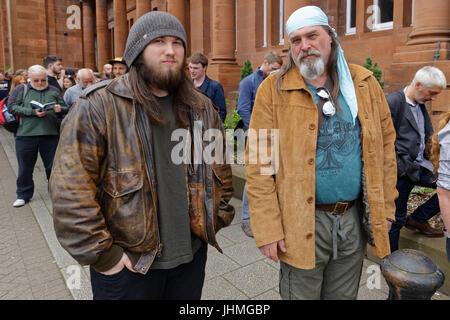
top-left (237, 52), bottom-right (283, 237)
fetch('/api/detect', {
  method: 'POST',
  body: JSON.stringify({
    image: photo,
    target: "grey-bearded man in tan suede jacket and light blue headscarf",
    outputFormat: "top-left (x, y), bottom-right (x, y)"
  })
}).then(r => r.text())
top-left (246, 6), bottom-right (397, 299)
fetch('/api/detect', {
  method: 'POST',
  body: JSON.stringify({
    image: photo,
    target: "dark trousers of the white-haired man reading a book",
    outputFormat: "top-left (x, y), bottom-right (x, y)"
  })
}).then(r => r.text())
top-left (16, 135), bottom-right (59, 201)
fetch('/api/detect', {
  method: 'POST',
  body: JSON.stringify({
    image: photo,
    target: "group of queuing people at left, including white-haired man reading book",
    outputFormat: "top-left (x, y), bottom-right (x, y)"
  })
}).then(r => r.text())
top-left (0, 55), bottom-right (134, 208)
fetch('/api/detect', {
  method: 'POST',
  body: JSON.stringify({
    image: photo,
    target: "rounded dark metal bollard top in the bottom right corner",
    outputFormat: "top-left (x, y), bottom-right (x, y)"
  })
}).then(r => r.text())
top-left (380, 249), bottom-right (445, 300)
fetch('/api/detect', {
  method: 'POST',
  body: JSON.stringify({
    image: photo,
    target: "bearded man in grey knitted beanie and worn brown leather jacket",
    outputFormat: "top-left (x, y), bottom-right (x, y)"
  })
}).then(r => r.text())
top-left (50, 11), bottom-right (234, 299)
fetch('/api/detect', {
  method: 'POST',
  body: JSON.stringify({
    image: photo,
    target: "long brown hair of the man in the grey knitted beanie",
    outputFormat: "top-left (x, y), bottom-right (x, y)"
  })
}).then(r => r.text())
top-left (128, 54), bottom-right (199, 128)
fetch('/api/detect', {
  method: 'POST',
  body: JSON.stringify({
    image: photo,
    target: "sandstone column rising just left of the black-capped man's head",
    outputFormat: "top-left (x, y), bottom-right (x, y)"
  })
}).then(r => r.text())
top-left (95, 0), bottom-right (112, 72)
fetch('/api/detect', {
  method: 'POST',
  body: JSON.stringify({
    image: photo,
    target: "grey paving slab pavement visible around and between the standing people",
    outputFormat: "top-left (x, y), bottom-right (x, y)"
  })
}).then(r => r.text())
top-left (0, 128), bottom-right (449, 300)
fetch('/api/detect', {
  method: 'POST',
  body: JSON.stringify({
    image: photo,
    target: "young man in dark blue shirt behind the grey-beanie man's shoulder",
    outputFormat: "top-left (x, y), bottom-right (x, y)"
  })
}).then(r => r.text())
top-left (189, 53), bottom-right (227, 122)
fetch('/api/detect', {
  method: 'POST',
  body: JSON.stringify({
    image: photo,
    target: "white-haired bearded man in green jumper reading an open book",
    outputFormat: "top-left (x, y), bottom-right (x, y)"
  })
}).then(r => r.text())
top-left (8, 65), bottom-right (67, 207)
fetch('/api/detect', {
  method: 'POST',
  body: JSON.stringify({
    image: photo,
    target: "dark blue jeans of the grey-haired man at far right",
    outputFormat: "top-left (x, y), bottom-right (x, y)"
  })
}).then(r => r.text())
top-left (389, 167), bottom-right (440, 252)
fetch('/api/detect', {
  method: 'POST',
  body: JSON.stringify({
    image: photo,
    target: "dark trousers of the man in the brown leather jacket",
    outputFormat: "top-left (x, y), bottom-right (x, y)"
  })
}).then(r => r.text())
top-left (90, 243), bottom-right (208, 300)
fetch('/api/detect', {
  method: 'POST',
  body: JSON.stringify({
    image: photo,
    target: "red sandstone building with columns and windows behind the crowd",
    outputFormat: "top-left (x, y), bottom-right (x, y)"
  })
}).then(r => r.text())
top-left (0, 0), bottom-right (450, 121)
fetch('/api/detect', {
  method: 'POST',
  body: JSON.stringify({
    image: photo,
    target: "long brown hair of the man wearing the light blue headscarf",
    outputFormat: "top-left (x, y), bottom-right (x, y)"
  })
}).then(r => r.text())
top-left (276, 26), bottom-right (339, 108)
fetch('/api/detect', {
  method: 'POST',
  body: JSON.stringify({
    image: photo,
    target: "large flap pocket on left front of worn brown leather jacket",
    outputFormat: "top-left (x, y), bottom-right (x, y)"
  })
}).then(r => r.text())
top-left (101, 171), bottom-right (146, 247)
